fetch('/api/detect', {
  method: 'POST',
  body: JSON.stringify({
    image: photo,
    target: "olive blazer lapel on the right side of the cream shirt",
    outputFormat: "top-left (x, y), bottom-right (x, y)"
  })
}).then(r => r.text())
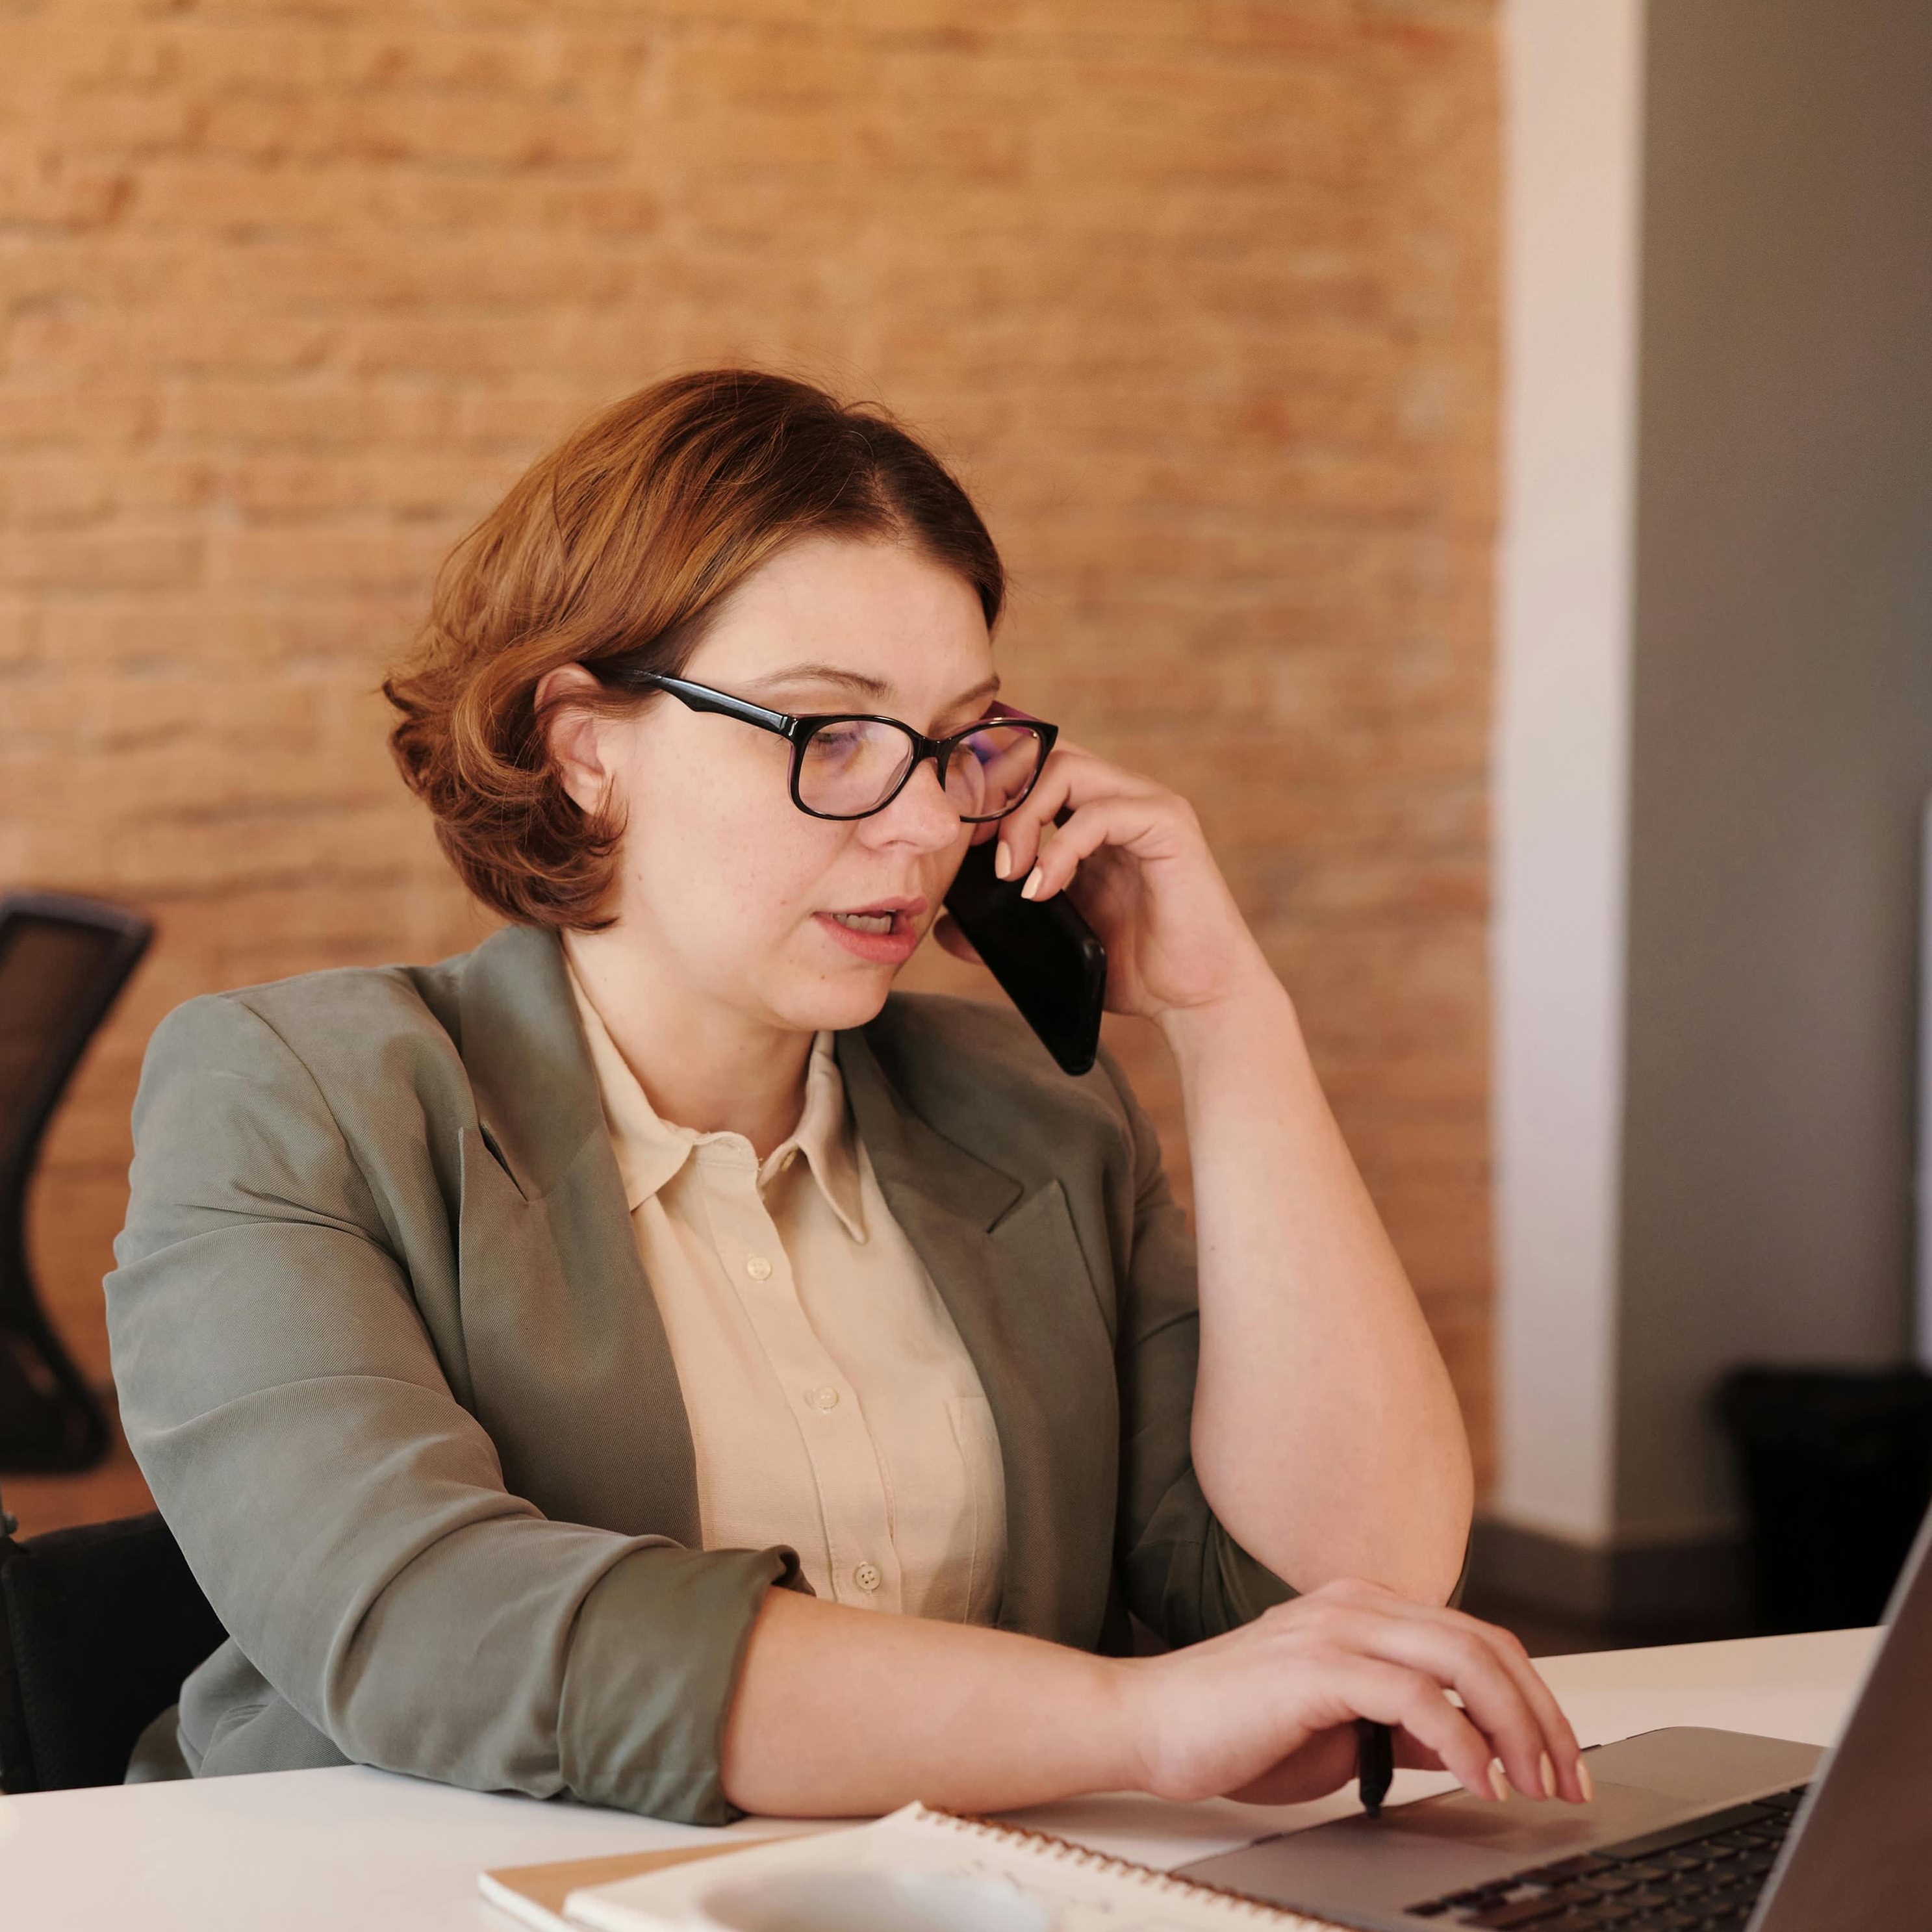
top-left (839, 1022), bottom-right (1121, 1646)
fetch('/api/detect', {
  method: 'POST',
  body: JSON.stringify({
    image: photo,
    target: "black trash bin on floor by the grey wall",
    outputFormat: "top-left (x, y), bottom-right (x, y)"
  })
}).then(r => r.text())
top-left (1718, 1368), bottom-right (1932, 1633)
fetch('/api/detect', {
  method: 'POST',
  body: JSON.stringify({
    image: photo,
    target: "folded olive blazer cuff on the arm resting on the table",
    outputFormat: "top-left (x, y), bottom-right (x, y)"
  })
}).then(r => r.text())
top-left (557, 1544), bottom-right (811, 1824)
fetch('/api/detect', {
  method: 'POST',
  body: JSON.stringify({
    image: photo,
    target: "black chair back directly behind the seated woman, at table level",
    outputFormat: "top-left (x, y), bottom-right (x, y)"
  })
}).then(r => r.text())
top-left (0, 1515), bottom-right (226, 1791)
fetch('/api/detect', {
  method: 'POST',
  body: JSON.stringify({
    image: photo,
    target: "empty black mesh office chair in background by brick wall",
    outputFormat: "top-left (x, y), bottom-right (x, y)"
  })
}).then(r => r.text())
top-left (0, 893), bottom-right (155, 1472)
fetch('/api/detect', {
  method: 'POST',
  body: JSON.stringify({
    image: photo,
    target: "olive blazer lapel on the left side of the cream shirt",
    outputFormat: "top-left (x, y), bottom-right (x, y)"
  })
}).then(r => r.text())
top-left (446, 926), bottom-right (702, 1547)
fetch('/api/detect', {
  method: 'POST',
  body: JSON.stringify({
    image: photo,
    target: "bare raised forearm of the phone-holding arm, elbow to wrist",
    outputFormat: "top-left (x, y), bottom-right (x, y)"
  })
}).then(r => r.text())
top-left (1163, 974), bottom-right (1472, 1601)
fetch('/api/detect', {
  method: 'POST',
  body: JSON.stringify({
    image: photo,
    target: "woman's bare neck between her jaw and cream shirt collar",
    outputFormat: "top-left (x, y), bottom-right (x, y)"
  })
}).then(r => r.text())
top-left (564, 929), bottom-right (813, 1159)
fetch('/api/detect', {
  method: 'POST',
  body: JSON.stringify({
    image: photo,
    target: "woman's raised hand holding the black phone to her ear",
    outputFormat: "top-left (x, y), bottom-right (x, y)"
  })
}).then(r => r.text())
top-left (937, 738), bottom-right (1269, 1020)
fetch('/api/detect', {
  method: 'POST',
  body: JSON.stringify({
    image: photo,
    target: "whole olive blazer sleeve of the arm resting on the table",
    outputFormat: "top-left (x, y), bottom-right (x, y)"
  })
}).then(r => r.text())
top-left (107, 997), bottom-right (798, 1824)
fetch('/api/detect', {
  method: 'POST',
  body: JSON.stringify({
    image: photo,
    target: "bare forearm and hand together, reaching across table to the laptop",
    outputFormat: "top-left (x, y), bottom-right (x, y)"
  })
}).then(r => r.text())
top-left (722, 1582), bottom-right (1588, 1818)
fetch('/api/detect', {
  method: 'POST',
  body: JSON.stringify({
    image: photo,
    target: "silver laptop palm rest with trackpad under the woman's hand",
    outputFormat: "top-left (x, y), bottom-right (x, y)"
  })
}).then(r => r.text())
top-left (1180, 1729), bottom-right (1818, 1916)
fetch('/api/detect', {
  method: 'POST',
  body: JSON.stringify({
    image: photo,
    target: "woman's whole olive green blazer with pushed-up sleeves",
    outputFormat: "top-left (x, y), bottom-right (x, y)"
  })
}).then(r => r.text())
top-left (107, 928), bottom-right (1291, 1824)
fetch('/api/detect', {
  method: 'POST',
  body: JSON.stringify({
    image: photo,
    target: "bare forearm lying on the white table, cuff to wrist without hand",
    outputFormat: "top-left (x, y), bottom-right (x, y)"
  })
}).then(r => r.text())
top-left (722, 1590), bottom-right (1138, 1818)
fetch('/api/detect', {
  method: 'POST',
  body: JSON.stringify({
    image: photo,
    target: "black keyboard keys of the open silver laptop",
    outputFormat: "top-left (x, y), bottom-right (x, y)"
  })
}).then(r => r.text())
top-left (1408, 1785), bottom-right (1805, 1932)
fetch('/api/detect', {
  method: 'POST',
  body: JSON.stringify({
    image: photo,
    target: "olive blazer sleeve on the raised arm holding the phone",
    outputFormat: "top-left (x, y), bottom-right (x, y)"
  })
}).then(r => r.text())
top-left (1101, 1051), bottom-right (1295, 1644)
